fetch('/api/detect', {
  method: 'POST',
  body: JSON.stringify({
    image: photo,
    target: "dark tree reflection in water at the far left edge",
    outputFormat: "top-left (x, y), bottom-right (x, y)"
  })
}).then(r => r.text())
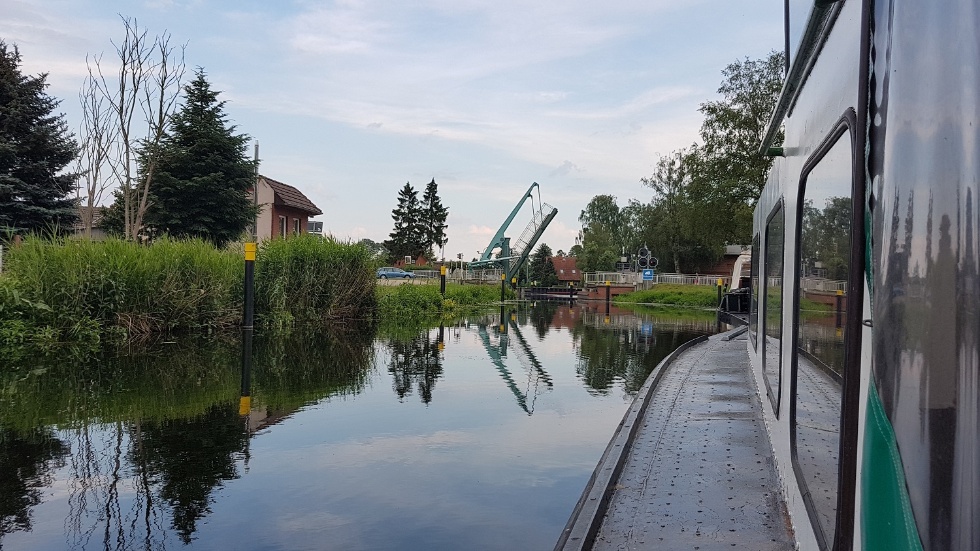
top-left (0, 427), bottom-right (68, 547)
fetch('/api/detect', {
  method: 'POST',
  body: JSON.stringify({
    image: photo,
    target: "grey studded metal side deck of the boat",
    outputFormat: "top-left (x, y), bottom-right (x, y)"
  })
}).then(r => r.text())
top-left (556, 333), bottom-right (795, 550)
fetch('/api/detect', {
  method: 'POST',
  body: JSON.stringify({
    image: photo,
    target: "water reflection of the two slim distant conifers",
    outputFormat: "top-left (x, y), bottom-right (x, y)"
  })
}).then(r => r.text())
top-left (388, 332), bottom-right (442, 404)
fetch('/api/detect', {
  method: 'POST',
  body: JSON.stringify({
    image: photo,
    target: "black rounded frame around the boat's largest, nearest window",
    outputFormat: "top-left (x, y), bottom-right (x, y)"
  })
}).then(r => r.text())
top-left (789, 108), bottom-right (866, 550)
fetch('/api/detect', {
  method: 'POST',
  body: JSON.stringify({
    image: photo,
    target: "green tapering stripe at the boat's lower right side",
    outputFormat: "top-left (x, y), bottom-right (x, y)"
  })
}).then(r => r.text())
top-left (861, 380), bottom-right (922, 551)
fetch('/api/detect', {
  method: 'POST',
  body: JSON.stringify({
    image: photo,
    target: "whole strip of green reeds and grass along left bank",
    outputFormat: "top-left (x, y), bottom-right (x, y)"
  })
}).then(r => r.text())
top-left (0, 235), bottom-right (513, 348)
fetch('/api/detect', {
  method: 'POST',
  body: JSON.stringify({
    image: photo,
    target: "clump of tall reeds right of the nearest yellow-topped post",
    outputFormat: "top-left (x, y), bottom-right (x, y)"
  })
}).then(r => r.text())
top-left (255, 235), bottom-right (375, 327)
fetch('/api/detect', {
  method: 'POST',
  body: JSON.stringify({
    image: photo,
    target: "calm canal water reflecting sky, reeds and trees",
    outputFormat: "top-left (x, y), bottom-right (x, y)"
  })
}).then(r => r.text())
top-left (0, 303), bottom-right (715, 550)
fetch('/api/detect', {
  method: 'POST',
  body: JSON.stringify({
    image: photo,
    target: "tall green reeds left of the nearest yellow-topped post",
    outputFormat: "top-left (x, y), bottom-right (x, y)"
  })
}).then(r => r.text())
top-left (4, 238), bottom-right (242, 335)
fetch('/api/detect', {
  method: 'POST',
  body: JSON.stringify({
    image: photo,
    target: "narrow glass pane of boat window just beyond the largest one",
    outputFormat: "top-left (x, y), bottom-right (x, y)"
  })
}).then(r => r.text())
top-left (762, 202), bottom-right (786, 417)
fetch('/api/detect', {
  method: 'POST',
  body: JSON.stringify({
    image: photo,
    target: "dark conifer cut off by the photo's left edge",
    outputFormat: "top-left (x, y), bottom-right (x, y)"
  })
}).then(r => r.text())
top-left (0, 40), bottom-right (78, 232)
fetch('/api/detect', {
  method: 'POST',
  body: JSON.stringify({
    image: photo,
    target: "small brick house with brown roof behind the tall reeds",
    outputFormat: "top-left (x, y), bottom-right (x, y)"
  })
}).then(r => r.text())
top-left (256, 175), bottom-right (323, 241)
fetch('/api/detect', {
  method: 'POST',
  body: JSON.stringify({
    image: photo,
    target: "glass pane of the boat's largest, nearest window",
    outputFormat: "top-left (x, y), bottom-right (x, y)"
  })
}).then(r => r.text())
top-left (790, 133), bottom-right (851, 549)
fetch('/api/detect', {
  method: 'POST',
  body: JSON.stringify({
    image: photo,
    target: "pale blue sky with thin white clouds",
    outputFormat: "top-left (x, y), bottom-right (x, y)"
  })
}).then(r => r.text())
top-left (0, 0), bottom-right (808, 259)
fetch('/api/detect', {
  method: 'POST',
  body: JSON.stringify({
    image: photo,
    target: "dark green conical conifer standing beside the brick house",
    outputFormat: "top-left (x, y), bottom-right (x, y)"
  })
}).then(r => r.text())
top-left (140, 69), bottom-right (255, 246)
